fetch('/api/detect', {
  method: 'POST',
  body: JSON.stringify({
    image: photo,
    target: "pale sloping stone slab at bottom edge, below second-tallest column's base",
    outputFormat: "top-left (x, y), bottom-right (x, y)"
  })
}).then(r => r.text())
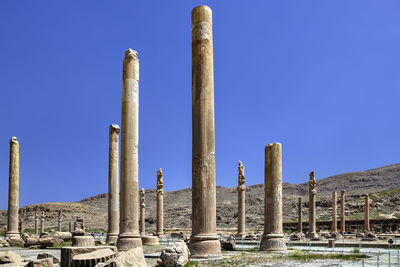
top-left (96, 247), bottom-right (147, 267)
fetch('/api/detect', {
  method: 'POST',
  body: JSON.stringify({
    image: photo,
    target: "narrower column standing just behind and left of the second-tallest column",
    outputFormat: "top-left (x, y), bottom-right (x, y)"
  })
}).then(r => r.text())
top-left (106, 124), bottom-right (120, 244)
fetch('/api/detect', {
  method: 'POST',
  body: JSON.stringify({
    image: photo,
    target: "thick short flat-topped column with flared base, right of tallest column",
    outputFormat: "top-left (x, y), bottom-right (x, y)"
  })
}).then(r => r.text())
top-left (260, 143), bottom-right (287, 251)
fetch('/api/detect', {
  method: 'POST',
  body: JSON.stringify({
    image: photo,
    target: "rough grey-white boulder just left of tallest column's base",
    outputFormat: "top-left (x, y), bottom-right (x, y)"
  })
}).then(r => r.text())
top-left (157, 241), bottom-right (190, 267)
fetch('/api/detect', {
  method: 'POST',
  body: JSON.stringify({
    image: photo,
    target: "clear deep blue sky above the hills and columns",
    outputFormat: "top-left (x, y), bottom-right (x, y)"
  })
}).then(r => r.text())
top-left (0, 0), bottom-right (400, 209)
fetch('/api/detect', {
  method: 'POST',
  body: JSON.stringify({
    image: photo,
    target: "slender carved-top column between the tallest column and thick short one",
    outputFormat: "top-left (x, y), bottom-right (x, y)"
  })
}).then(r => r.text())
top-left (236, 161), bottom-right (246, 238)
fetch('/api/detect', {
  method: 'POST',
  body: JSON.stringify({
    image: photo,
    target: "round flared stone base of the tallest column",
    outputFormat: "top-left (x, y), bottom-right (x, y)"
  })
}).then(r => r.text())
top-left (188, 235), bottom-right (222, 259)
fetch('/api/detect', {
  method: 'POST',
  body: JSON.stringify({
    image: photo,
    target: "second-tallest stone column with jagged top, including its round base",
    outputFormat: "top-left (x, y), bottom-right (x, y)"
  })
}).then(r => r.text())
top-left (117, 49), bottom-right (142, 251)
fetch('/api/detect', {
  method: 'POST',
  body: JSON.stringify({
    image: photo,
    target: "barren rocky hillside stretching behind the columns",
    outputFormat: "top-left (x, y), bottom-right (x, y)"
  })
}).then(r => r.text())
top-left (0, 164), bottom-right (400, 232)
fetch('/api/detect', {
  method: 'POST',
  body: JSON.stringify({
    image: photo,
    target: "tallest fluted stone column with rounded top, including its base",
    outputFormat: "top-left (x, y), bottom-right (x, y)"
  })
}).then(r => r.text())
top-left (188, 6), bottom-right (221, 258)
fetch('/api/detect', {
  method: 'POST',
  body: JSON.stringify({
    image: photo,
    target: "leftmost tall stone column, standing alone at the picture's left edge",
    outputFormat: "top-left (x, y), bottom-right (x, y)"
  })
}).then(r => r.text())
top-left (6, 137), bottom-right (20, 238)
